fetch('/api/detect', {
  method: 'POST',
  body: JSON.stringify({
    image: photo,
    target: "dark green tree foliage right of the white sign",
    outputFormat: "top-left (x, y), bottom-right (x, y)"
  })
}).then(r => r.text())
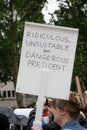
top-left (50, 0), bottom-right (87, 87)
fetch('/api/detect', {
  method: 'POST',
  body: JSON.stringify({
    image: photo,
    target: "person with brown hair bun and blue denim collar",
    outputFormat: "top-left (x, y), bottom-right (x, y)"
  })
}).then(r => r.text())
top-left (32, 92), bottom-right (85, 130)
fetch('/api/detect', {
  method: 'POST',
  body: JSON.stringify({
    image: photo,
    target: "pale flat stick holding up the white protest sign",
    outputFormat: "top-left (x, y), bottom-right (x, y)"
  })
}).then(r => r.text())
top-left (35, 71), bottom-right (48, 121)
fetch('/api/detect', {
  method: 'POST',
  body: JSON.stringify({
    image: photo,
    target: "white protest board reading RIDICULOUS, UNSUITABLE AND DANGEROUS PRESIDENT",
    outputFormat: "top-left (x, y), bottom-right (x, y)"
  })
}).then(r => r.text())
top-left (16, 22), bottom-right (78, 99)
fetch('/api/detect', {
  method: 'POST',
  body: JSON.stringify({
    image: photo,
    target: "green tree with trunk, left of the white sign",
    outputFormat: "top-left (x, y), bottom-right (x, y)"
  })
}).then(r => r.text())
top-left (0, 0), bottom-right (46, 106)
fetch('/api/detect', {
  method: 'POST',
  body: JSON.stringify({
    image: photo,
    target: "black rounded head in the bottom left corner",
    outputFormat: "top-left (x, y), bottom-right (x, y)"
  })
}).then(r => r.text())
top-left (0, 113), bottom-right (10, 130)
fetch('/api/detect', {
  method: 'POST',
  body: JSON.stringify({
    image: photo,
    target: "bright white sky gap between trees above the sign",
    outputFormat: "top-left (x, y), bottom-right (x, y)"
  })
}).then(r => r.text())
top-left (42, 0), bottom-right (58, 23)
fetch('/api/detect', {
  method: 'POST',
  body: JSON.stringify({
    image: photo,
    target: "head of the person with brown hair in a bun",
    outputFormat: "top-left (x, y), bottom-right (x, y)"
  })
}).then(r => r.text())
top-left (52, 92), bottom-right (84, 125)
